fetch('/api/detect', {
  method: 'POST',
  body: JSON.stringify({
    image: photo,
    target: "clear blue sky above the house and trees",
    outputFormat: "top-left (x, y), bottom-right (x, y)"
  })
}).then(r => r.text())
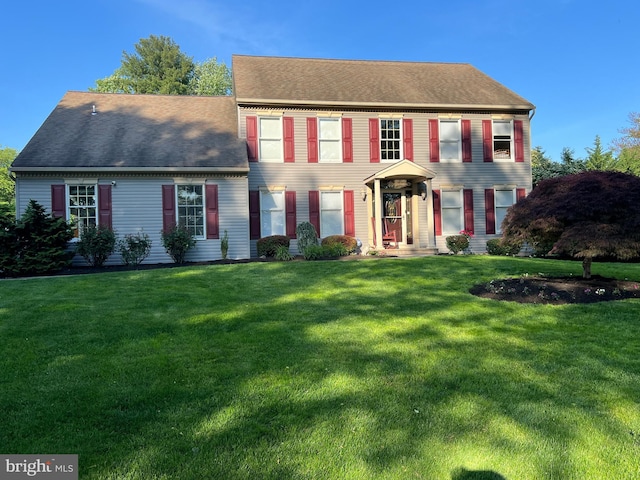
top-left (0, 0), bottom-right (640, 160)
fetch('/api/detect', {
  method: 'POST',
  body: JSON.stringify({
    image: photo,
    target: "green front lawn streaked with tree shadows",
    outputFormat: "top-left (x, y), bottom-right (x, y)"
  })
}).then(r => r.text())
top-left (0, 256), bottom-right (640, 480)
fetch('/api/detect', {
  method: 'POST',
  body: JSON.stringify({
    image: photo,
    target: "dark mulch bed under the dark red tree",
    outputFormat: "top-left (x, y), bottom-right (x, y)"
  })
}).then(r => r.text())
top-left (469, 275), bottom-right (640, 305)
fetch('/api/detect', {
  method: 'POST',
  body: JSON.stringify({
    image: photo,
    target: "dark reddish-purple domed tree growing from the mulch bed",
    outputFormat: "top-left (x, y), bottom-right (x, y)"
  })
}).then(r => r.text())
top-left (502, 171), bottom-right (640, 278)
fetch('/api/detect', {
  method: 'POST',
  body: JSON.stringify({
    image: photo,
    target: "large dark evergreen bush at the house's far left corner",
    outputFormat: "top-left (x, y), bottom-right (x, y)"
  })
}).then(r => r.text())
top-left (0, 200), bottom-right (73, 276)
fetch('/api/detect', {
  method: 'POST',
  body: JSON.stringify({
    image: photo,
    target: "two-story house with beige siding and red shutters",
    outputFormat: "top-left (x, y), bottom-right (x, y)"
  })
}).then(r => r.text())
top-left (11, 55), bottom-right (534, 264)
